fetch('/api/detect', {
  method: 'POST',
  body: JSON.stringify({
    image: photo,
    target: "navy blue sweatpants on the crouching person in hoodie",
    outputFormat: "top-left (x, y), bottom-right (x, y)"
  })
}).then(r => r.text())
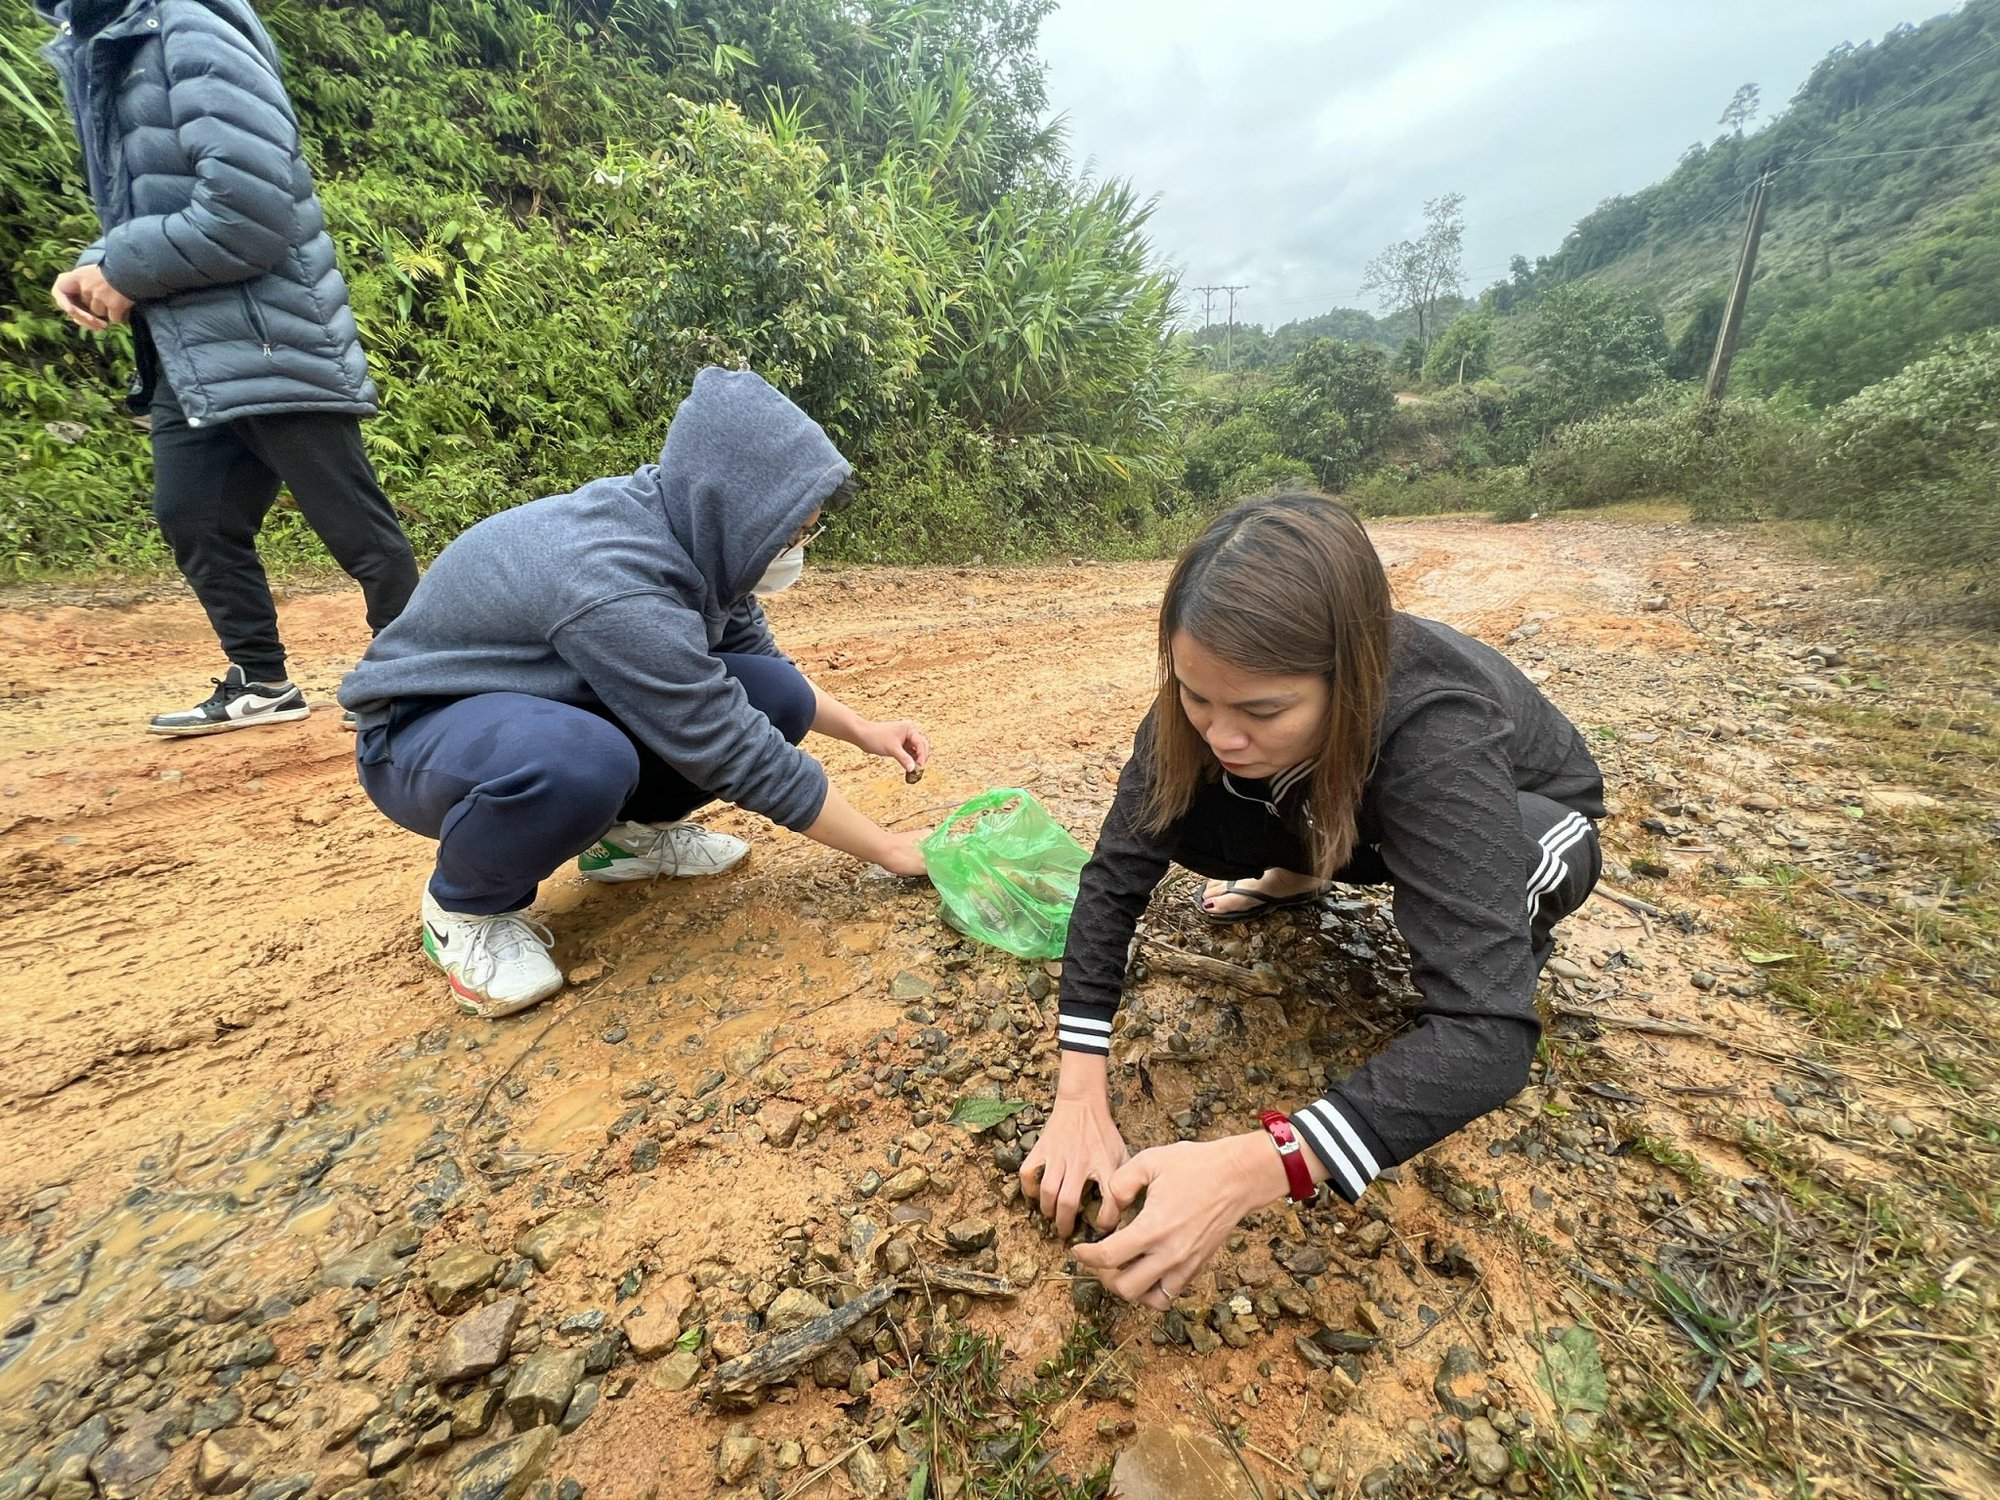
top-left (354, 652), bottom-right (814, 916)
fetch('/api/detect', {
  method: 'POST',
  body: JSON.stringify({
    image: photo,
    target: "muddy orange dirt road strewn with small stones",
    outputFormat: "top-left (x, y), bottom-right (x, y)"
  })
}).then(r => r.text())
top-left (0, 520), bottom-right (1992, 1500)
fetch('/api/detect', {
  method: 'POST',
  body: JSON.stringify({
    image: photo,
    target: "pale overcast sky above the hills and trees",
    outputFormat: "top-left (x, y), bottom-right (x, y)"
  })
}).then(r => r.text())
top-left (1042, 0), bottom-right (1954, 326)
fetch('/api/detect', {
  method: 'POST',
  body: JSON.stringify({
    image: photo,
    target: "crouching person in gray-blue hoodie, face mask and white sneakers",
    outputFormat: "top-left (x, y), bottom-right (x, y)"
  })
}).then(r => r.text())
top-left (340, 370), bottom-right (930, 1016)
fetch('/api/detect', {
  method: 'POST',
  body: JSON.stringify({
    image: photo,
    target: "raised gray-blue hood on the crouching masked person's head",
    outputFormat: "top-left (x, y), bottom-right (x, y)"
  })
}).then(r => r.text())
top-left (652, 368), bottom-right (854, 614)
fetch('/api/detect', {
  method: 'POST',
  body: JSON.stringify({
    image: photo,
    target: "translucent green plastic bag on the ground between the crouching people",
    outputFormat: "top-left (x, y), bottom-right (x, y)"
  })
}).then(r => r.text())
top-left (924, 786), bottom-right (1090, 958)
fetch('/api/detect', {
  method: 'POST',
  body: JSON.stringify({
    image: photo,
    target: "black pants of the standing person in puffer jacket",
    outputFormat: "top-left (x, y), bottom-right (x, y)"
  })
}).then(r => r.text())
top-left (152, 380), bottom-right (416, 682)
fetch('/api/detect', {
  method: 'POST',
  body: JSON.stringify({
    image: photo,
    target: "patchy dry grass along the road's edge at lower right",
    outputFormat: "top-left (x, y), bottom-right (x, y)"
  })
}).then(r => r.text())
top-left (1532, 662), bottom-right (2000, 1500)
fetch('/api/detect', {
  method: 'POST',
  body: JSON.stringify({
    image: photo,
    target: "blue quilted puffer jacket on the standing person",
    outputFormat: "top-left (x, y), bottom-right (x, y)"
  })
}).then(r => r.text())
top-left (36, 0), bottom-right (376, 426)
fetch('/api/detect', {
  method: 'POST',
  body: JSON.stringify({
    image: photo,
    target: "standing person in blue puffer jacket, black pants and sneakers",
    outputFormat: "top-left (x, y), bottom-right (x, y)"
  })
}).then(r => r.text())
top-left (36, 0), bottom-right (416, 734)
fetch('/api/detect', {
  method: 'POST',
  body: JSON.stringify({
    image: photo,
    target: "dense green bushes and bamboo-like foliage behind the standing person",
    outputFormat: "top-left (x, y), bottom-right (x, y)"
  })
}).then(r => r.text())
top-left (0, 0), bottom-right (1180, 570)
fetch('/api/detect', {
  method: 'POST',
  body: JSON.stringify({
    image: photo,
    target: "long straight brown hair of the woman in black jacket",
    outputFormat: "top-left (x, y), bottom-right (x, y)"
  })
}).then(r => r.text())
top-left (1144, 494), bottom-right (1394, 878)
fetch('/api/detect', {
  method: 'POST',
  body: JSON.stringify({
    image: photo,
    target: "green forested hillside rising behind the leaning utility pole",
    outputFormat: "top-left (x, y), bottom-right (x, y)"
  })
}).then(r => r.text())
top-left (1492, 0), bottom-right (2000, 406)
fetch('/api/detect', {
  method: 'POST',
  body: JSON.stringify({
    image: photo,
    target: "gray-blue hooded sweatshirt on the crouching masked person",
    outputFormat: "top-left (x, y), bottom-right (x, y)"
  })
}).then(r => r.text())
top-left (340, 368), bottom-right (852, 830)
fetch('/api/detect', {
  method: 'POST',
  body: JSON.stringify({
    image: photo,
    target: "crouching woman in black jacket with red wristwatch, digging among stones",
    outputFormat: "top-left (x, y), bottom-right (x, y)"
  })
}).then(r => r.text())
top-left (1022, 494), bottom-right (1604, 1308)
